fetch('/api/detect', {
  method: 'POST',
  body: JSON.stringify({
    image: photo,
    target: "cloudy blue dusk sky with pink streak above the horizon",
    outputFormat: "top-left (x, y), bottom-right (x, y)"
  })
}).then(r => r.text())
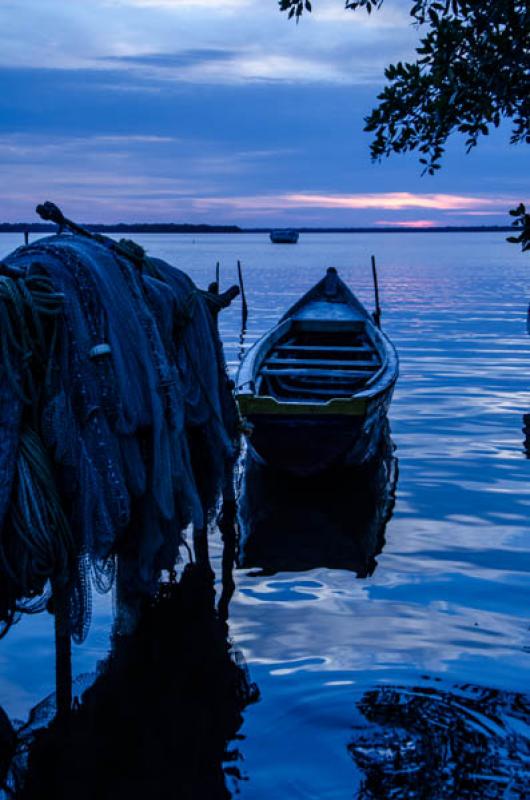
top-left (0, 0), bottom-right (530, 227)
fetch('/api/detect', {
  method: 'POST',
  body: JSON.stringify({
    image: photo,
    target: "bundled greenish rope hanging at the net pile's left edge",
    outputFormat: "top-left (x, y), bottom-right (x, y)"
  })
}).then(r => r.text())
top-left (0, 272), bottom-right (75, 635)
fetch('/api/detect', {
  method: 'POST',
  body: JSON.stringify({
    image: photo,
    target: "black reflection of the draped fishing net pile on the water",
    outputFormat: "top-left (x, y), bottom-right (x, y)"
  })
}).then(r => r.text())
top-left (0, 531), bottom-right (258, 800)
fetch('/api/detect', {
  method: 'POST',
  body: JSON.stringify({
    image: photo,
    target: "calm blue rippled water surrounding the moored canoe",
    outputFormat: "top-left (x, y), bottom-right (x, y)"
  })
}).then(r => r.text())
top-left (0, 234), bottom-right (530, 800)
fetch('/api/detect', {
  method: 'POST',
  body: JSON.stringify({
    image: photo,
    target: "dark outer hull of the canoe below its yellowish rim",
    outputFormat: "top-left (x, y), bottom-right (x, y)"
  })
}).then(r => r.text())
top-left (246, 387), bottom-right (393, 476)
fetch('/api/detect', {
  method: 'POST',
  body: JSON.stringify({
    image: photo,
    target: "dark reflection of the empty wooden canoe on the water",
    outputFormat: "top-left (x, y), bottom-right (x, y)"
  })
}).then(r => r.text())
top-left (238, 420), bottom-right (398, 578)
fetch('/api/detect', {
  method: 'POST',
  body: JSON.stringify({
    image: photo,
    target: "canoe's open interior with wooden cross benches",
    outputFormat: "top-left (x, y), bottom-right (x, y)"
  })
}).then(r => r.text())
top-left (256, 320), bottom-right (382, 402)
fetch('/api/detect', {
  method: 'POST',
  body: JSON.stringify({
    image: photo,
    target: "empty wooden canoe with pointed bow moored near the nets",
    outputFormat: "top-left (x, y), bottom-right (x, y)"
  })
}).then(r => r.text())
top-left (236, 268), bottom-right (399, 475)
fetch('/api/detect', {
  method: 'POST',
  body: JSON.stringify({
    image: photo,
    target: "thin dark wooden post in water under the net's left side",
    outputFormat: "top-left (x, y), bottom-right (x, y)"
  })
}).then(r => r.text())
top-left (53, 582), bottom-right (72, 720)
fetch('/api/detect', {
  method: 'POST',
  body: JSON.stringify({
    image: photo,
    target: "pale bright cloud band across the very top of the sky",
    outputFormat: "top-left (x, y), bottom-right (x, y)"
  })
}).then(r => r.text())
top-left (0, 0), bottom-right (417, 85)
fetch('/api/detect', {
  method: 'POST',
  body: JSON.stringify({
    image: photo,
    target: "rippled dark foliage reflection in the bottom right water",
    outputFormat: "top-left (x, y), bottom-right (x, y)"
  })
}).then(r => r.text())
top-left (348, 680), bottom-right (530, 800)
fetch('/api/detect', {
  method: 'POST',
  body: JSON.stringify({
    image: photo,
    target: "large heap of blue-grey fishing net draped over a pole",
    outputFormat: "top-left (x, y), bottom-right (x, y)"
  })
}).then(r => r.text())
top-left (0, 234), bottom-right (239, 641)
